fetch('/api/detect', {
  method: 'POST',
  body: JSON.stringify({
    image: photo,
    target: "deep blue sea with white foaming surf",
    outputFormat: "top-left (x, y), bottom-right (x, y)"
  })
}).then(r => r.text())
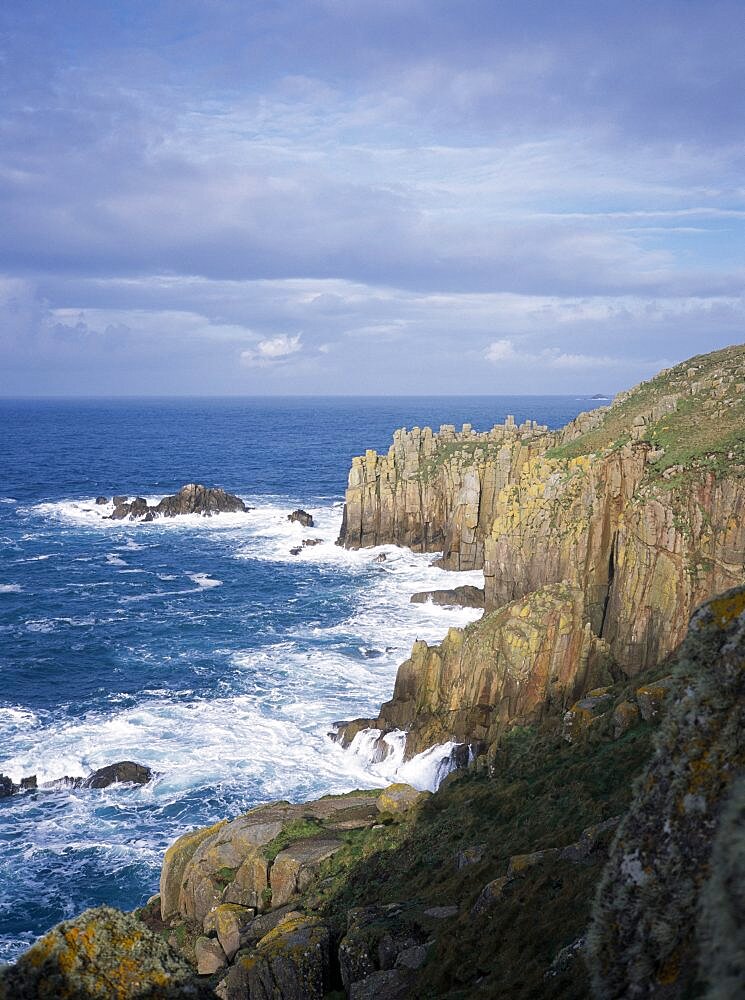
top-left (0, 396), bottom-right (597, 961)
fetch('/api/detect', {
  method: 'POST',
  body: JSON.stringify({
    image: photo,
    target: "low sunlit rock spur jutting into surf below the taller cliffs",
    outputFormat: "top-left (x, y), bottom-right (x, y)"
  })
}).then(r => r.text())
top-left (339, 584), bottom-right (613, 759)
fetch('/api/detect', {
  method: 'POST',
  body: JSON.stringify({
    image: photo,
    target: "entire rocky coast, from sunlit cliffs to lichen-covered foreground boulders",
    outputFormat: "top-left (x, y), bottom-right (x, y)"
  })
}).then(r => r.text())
top-left (0, 347), bottom-right (745, 1000)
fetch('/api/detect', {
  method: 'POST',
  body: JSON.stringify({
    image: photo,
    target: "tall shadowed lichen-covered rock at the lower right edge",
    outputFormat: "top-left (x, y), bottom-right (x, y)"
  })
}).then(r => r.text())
top-left (588, 587), bottom-right (745, 1000)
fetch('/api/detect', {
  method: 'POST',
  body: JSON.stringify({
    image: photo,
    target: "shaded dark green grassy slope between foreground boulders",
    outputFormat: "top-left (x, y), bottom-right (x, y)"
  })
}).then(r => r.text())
top-left (307, 665), bottom-right (666, 1000)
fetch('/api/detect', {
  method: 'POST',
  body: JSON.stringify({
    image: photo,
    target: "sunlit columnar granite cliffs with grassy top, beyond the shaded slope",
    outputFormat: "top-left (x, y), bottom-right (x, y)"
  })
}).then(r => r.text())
top-left (342, 347), bottom-right (745, 754)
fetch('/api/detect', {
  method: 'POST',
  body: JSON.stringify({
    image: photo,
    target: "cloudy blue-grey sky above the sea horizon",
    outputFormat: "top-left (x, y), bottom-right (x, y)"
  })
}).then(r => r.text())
top-left (0, 0), bottom-right (745, 396)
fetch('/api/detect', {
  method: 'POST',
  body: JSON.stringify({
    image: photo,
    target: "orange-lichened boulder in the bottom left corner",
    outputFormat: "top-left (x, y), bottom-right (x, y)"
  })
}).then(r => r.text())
top-left (0, 906), bottom-right (204, 1000)
